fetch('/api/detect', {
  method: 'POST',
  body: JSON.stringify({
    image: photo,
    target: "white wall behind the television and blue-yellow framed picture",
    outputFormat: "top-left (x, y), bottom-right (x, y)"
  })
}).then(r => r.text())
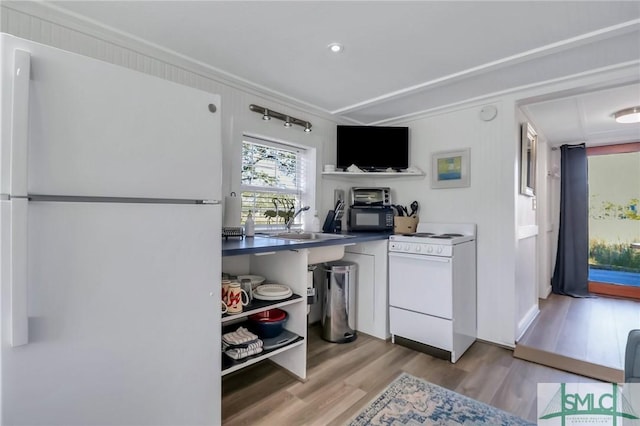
top-left (323, 101), bottom-right (516, 346)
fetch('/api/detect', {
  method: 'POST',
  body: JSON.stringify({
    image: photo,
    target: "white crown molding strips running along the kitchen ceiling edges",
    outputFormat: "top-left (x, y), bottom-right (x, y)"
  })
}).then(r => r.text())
top-left (6, 0), bottom-right (640, 125)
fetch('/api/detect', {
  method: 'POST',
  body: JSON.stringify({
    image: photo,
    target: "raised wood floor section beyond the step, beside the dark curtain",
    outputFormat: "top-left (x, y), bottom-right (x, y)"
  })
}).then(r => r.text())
top-left (515, 294), bottom-right (640, 382)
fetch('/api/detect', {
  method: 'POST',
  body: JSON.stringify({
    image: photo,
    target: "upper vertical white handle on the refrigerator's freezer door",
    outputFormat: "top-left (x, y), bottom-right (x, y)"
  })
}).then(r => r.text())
top-left (10, 49), bottom-right (31, 196)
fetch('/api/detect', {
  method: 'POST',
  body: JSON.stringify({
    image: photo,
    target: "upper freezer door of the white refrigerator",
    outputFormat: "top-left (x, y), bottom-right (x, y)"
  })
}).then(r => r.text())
top-left (0, 34), bottom-right (222, 200)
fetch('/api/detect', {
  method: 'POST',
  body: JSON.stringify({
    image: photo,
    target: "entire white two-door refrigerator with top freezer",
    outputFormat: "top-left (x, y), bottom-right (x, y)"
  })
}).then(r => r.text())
top-left (0, 34), bottom-right (221, 425)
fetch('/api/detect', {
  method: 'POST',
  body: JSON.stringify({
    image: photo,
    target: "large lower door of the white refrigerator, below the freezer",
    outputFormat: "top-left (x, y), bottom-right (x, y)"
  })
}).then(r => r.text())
top-left (2, 202), bottom-right (221, 425)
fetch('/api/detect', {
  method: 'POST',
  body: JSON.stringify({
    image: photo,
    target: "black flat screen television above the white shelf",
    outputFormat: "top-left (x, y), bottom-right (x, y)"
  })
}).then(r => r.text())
top-left (336, 125), bottom-right (409, 171)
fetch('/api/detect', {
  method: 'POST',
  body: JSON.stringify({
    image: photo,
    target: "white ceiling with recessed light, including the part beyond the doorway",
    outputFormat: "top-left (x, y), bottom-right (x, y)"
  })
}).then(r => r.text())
top-left (47, 1), bottom-right (640, 144)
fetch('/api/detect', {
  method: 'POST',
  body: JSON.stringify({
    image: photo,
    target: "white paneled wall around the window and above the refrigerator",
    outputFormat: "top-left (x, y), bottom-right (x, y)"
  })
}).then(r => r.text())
top-left (0, 2), bottom-right (336, 216)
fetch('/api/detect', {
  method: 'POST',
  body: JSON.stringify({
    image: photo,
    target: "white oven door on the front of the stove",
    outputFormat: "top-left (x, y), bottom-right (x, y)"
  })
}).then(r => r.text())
top-left (389, 252), bottom-right (453, 319)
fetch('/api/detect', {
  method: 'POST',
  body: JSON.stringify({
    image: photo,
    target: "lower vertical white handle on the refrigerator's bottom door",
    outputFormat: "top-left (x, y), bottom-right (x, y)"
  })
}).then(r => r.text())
top-left (9, 198), bottom-right (29, 347)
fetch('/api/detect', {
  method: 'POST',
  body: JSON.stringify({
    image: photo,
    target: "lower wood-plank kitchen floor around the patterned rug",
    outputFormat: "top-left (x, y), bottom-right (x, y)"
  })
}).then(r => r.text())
top-left (222, 326), bottom-right (594, 425)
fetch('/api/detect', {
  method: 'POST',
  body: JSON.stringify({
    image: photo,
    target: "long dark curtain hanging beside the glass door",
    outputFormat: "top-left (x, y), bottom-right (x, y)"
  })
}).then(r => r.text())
top-left (551, 144), bottom-right (589, 297)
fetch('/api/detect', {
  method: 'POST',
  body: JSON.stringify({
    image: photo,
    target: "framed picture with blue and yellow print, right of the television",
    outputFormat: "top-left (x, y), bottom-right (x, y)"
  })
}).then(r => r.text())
top-left (431, 148), bottom-right (471, 189)
